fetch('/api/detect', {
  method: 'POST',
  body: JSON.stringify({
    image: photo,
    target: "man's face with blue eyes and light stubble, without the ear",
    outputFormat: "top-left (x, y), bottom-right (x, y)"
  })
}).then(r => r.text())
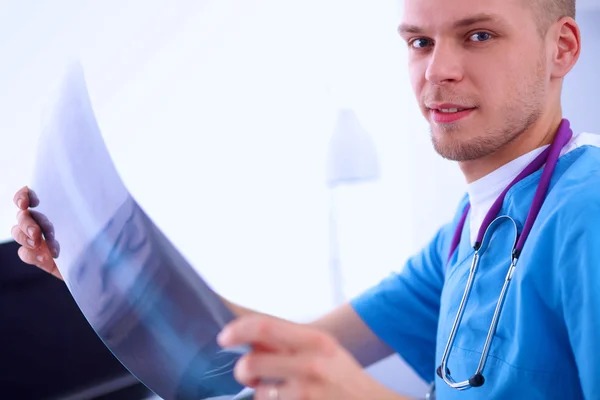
top-left (399, 0), bottom-right (550, 161)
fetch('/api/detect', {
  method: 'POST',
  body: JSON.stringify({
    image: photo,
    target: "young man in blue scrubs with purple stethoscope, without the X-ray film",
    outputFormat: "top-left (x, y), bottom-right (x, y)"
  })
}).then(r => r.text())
top-left (12, 0), bottom-right (600, 400)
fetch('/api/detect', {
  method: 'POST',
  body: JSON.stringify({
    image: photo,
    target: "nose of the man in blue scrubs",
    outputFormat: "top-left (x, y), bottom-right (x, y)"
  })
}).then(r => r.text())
top-left (425, 44), bottom-right (464, 85)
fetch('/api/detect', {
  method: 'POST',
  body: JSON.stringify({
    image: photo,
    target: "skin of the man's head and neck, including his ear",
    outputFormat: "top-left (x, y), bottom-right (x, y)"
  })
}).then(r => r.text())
top-left (399, 0), bottom-right (580, 183)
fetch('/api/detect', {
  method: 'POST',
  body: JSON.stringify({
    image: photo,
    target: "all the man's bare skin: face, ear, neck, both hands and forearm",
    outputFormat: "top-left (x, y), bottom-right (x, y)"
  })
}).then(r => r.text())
top-left (12, 0), bottom-right (580, 400)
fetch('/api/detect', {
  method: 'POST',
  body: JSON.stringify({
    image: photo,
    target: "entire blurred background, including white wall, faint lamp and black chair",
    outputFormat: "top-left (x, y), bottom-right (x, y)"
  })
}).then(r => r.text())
top-left (0, 0), bottom-right (600, 399)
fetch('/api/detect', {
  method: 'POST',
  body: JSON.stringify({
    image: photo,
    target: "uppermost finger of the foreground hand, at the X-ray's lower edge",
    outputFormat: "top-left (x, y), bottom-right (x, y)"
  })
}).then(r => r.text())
top-left (218, 314), bottom-right (336, 355)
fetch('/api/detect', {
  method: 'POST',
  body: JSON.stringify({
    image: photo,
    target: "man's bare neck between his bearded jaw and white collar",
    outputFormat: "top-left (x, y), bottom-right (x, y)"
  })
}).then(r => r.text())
top-left (459, 112), bottom-right (562, 184)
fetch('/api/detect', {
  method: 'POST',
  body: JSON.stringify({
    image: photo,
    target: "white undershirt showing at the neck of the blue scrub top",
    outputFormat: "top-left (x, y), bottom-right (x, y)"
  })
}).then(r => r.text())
top-left (467, 133), bottom-right (600, 245)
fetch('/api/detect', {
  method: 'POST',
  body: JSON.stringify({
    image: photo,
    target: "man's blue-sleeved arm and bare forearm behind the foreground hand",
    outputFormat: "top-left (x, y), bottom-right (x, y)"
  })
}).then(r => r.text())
top-left (224, 215), bottom-right (460, 382)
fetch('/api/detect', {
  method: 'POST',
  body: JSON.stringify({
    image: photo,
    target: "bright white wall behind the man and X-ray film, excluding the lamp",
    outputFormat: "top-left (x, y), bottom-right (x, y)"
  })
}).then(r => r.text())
top-left (0, 0), bottom-right (433, 393)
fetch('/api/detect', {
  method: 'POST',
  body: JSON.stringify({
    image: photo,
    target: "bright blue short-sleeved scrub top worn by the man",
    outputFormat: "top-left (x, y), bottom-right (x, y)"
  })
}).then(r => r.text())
top-left (351, 146), bottom-right (600, 400)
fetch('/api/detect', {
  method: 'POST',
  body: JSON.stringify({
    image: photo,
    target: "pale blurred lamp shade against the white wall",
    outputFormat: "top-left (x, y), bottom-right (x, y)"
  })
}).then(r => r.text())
top-left (327, 108), bottom-right (380, 187)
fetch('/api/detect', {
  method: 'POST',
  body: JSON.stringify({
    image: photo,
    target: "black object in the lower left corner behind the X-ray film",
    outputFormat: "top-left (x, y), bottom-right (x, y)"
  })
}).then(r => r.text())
top-left (0, 242), bottom-right (152, 400)
